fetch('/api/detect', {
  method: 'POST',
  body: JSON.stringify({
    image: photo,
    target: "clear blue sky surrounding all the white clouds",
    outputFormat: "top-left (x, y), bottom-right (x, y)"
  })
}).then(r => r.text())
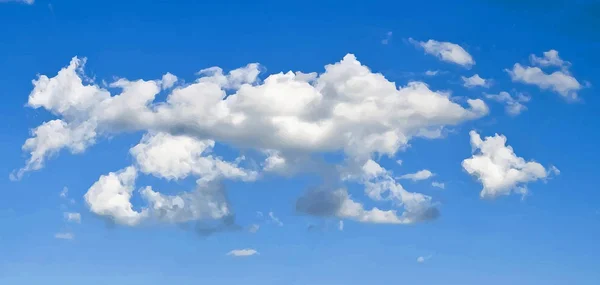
top-left (0, 0), bottom-right (600, 285)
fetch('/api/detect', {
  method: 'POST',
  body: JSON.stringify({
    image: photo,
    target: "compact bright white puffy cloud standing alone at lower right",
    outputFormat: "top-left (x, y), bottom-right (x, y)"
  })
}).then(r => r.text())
top-left (462, 131), bottom-right (556, 199)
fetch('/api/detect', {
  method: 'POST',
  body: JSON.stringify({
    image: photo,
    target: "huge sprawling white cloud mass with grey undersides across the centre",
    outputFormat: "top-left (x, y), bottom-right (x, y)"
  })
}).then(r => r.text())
top-left (12, 54), bottom-right (488, 226)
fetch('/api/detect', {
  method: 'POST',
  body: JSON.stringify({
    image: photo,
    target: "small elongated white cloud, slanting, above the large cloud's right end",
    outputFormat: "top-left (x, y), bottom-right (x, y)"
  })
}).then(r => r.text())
top-left (408, 38), bottom-right (475, 67)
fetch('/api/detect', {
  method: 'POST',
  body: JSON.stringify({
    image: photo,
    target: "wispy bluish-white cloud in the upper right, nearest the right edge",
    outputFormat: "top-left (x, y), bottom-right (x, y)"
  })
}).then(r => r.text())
top-left (506, 50), bottom-right (583, 99)
